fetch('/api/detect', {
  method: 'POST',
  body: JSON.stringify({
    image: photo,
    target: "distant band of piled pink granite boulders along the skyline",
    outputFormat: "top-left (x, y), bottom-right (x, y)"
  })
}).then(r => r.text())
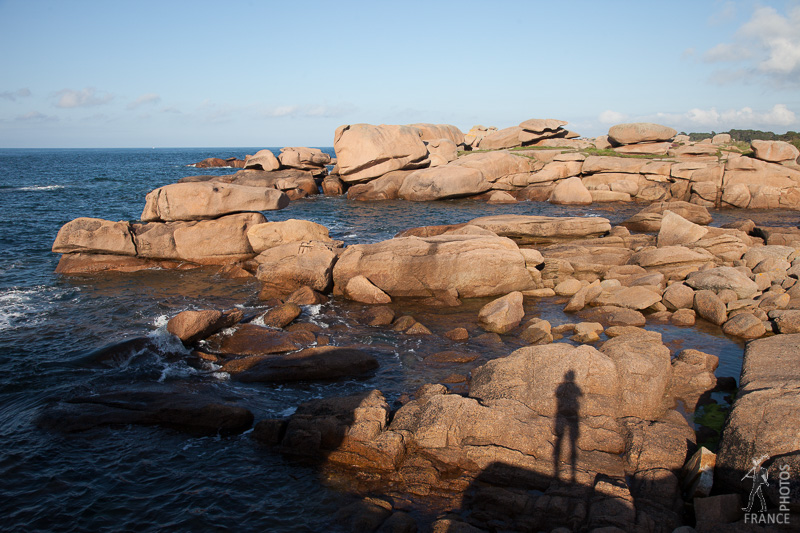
top-left (330, 119), bottom-right (800, 208)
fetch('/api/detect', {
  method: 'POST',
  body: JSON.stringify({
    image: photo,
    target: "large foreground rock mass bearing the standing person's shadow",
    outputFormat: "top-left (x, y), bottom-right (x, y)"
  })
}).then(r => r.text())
top-left (254, 331), bottom-right (713, 531)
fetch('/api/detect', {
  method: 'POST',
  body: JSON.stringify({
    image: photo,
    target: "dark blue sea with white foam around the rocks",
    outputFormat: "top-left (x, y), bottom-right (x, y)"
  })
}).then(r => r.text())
top-left (0, 147), bottom-right (779, 532)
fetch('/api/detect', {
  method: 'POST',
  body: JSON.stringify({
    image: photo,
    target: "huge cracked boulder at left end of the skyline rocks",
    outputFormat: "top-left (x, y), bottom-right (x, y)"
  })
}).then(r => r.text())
top-left (333, 124), bottom-right (429, 183)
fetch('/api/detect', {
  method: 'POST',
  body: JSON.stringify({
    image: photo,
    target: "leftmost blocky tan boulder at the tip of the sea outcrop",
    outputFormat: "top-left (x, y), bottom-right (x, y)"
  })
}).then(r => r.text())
top-left (53, 217), bottom-right (136, 255)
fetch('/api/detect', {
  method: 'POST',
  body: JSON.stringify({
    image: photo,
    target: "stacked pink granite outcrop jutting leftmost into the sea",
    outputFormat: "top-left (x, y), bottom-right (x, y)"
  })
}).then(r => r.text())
top-left (53, 181), bottom-right (289, 274)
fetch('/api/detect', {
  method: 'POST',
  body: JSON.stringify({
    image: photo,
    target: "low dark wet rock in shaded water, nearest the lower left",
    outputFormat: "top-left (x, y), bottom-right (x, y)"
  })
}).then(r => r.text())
top-left (36, 388), bottom-right (253, 435)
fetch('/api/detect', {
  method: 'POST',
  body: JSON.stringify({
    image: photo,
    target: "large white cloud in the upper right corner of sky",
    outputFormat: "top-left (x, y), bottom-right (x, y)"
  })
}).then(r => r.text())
top-left (704, 6), bottom-right (800, 86)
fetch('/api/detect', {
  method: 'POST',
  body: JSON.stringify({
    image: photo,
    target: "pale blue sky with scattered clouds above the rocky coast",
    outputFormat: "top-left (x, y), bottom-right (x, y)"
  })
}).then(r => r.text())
top-left (0, 0), bottom-right (800, 148)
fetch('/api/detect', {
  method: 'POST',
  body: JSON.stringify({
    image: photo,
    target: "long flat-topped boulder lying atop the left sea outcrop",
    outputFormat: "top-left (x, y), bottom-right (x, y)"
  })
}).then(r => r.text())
top-left (142, 182), bottom-right (289, 222)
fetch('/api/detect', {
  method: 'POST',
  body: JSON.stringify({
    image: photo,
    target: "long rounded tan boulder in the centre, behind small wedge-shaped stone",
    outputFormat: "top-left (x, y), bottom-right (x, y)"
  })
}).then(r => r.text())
top-left (333, 234), bottom-right (534, 298)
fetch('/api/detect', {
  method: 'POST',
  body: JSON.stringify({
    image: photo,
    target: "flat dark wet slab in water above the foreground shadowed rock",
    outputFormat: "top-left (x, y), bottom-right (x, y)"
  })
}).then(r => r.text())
top-left (234, 346), bottom-right (379, 383)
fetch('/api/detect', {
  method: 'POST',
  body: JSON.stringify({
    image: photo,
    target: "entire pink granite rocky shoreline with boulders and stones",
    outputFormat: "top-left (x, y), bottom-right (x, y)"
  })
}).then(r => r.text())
top-left (45, 120), bottom-right (800, 531)
